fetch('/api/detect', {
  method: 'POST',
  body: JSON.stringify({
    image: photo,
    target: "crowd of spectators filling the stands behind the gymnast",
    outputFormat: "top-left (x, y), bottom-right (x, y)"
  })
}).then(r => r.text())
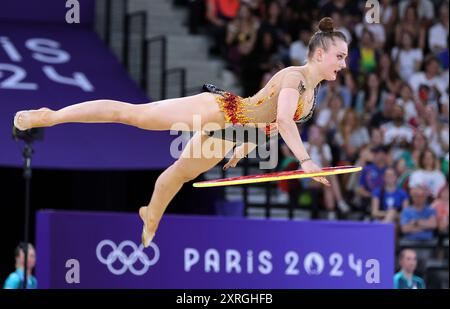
top-left (181, 0), bottom-right (449, 286)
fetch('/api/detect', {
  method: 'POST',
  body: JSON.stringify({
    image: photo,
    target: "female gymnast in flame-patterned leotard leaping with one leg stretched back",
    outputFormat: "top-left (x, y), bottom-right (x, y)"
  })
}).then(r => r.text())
top-left (14, 17), bottom-right (348, 247)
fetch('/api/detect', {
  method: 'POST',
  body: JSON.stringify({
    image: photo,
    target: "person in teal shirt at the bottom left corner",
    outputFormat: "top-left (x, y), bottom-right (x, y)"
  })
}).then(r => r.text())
top-left (3, 243), bottom-right (37, 289)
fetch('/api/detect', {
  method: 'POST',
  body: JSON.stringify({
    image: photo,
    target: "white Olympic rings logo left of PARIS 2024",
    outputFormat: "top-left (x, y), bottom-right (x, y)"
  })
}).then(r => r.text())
top-left (96, 239), bottom-right (159, 276)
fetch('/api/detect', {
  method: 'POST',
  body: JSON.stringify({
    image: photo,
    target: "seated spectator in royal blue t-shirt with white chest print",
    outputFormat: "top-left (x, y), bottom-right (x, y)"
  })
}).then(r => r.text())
top-left (372, 167), bottom-right (408, 223)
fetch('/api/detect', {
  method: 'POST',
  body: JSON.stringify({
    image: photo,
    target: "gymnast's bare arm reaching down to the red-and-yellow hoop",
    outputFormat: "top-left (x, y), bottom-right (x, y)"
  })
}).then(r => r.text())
top-left (277, 73), bottom-right (329, 185)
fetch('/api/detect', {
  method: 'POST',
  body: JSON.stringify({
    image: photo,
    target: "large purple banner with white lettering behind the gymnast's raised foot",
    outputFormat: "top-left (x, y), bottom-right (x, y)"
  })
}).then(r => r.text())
top-left (0, 22), bottom-right (174, 169)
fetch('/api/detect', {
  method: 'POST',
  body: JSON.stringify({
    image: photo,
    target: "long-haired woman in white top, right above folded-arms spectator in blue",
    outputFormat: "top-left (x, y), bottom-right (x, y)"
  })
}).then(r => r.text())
top-left (409, 149), bottom-right (446, 198)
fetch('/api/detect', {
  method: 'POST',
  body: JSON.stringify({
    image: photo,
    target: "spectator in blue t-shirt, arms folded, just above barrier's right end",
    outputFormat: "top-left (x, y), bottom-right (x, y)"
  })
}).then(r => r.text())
top-left (400, 186), bottom-right (437, 240)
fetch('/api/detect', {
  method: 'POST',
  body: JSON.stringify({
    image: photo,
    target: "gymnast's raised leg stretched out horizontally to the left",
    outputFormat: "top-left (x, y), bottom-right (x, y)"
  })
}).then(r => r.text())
top-left (14, 92), bottom-right (225, 130)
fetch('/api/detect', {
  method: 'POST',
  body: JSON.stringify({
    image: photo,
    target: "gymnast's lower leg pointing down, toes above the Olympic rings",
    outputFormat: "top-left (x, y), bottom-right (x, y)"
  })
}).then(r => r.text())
top-left (139, 132), bottom-right (234, 247)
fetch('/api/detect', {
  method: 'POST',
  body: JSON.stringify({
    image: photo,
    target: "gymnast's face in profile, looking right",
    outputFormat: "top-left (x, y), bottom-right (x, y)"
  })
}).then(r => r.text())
top-left (317, 38), bottom-right (348, 80)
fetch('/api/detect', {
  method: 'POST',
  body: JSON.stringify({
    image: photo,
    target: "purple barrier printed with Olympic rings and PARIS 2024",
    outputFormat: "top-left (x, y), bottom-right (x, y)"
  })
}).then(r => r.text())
top-left (36, 211), bottom-right (394, 289)
